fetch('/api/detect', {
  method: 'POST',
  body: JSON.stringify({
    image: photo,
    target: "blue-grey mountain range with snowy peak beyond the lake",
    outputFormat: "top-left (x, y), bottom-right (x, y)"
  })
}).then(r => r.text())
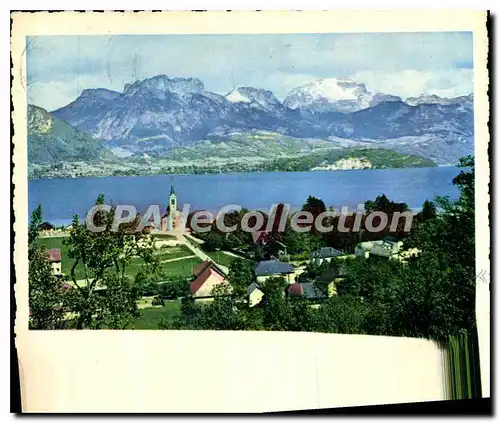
top-left (28, 75), bottom-right (473, 176)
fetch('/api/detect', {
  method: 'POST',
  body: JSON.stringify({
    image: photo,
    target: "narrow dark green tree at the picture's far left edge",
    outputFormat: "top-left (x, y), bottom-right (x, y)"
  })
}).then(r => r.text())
top-left (28, 205), bottom-right (65, 329)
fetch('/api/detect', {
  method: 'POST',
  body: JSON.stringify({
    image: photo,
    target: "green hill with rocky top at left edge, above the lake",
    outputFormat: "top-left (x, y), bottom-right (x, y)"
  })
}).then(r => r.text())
top-left (28, 105), bottom-right (112, 164)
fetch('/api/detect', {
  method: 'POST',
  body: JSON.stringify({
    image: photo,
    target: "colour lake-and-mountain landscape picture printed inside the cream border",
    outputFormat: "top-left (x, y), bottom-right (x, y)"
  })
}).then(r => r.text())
top-left (26, 32), bottom-right (476, 354)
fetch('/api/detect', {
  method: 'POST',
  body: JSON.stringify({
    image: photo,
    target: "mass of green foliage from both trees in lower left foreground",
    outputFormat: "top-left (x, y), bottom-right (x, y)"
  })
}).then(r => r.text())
top-left (29, 195), bottom-right (159, 329)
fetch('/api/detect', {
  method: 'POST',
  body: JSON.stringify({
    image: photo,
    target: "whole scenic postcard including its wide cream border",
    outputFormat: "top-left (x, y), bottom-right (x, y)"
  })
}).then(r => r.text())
top-left (11, 11), bottom-right (490, 412)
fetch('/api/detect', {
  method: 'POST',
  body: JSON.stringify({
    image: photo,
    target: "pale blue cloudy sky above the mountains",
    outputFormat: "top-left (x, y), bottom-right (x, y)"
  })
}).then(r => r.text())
top-left (27, 32), bottom-right (473, 111)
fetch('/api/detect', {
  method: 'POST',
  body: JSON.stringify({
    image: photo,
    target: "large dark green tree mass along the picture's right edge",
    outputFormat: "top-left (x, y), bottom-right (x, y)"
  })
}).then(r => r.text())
top-left (399, 156), bottom-right (476, 339)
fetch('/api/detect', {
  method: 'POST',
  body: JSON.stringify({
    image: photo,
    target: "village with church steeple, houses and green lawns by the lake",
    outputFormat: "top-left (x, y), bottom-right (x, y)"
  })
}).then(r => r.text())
top-left (39, 185), bottom-right (416, 329)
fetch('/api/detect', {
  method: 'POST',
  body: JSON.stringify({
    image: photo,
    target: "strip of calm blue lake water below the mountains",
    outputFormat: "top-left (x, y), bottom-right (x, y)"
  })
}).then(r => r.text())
top-left (28, 167), bottom-right (460, 225)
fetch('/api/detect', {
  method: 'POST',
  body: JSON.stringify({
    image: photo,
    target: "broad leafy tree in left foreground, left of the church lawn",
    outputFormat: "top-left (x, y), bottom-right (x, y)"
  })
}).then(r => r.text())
top-left (65, 195), bottom-right (159, 329)
